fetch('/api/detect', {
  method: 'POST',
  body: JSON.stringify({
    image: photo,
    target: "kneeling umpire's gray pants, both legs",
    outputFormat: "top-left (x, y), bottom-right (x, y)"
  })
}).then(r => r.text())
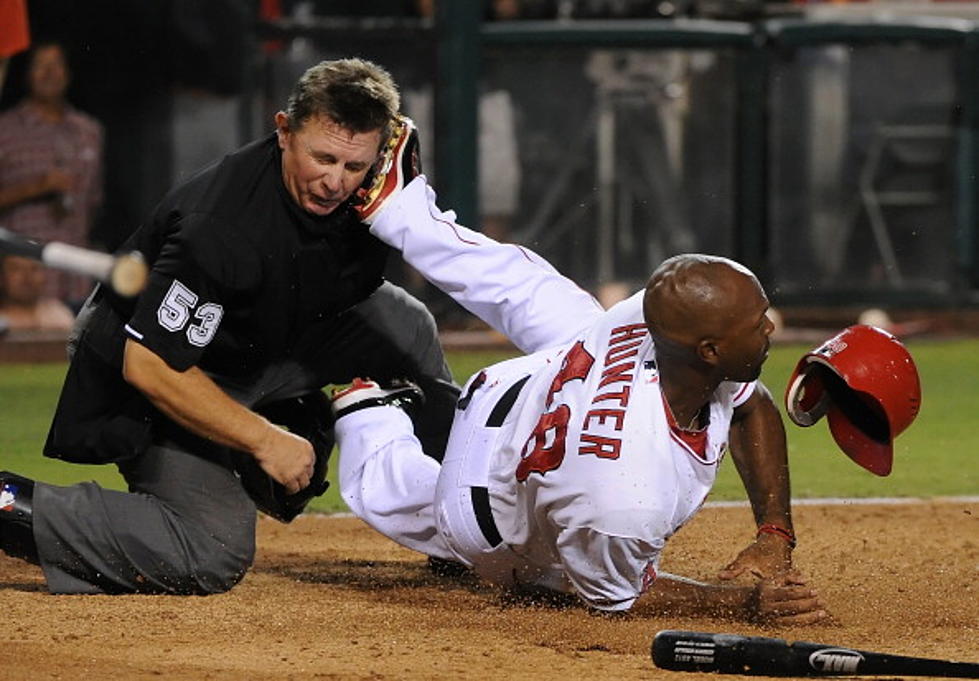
top-left (34, 284), bottom-right (458, 594)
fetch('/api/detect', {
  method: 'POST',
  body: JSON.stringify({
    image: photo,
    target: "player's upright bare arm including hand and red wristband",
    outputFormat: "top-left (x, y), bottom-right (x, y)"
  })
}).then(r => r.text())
top-left (719, 382), bottom-right (795, 579)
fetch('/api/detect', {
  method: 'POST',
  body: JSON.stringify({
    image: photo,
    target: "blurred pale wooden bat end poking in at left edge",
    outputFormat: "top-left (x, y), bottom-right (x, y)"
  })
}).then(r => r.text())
top-left (0, 227), bottom-right (149, 297)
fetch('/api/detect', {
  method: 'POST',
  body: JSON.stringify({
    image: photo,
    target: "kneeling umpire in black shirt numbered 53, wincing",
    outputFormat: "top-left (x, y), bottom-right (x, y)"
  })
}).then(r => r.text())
top-left (0, 59), bottom-right (458, 594)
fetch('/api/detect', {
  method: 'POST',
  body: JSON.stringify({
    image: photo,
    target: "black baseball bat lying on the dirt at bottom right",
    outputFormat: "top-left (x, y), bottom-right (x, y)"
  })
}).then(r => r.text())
top-left (652, 629), bottom-right (979, 679)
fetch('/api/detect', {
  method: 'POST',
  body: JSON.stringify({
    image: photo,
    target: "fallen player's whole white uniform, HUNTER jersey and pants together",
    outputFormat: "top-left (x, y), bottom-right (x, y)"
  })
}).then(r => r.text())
top-left (337, 178), bottom-right (754, 610)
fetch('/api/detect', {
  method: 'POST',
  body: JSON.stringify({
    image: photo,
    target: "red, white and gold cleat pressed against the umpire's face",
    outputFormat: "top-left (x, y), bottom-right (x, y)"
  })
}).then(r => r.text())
top-left (353, 115), bottom-right (421, 225)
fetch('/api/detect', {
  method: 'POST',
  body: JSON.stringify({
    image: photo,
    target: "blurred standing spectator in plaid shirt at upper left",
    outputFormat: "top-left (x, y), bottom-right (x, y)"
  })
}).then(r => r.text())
top-left (0, 42), bottom-right (103, 305)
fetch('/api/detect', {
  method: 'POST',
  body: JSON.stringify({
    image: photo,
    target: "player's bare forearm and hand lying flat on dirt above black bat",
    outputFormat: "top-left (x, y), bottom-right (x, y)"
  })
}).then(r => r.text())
top-left (631, 573), bottom-right (829, 626)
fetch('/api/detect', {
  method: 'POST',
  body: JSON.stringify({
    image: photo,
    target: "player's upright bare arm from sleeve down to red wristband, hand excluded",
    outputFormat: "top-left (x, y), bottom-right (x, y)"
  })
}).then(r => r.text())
top-left (730, 383), bottom-right (792, 532)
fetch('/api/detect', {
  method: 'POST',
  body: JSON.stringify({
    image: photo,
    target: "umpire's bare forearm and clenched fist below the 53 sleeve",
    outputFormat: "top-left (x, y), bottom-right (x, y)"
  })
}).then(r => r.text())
top-left (123, 339), bottom-right (315, 493)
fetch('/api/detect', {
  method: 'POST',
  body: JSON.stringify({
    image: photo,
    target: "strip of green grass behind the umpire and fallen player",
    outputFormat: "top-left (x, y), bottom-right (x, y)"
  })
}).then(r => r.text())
top-left (0, 341), bottom-right (979, 511)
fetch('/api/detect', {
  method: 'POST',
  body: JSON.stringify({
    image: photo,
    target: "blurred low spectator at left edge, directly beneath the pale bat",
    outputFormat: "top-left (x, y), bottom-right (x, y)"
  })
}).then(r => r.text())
top-left (0, 255), bottom-right (75, 333)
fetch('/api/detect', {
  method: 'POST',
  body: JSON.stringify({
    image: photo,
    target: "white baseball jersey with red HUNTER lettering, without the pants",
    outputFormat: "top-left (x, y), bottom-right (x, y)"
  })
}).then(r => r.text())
top-left (489, 293), bottom-right (753, 610)
